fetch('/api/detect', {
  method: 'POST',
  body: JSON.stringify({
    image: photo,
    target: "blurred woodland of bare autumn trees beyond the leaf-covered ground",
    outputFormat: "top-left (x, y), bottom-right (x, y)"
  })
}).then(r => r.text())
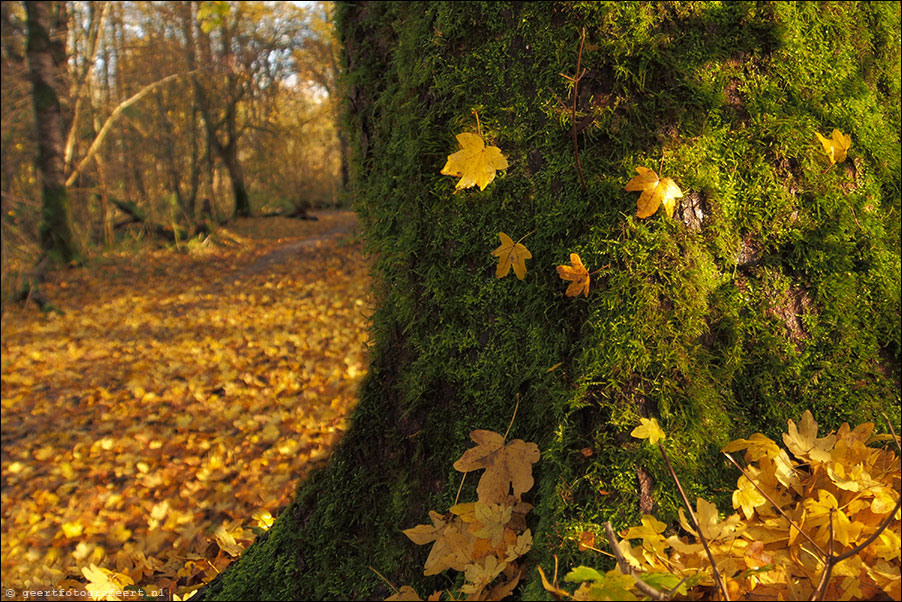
top-left (2, 2), bottom-right (346, 303)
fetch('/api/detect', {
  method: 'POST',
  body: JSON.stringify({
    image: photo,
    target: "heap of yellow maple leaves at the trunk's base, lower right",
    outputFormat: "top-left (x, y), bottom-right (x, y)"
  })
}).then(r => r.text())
top-left (545, 411), bottom-right (902, 600)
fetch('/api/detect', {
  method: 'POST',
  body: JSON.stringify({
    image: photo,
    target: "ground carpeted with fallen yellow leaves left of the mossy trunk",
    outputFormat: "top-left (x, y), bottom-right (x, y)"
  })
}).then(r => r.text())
top-left (2, 212), bottom-right (370, 599)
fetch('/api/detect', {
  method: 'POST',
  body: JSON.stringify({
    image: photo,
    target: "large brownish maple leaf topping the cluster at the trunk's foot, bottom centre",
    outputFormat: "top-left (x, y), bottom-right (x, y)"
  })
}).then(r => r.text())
top-left (454, 430), bottom-right (539, 504)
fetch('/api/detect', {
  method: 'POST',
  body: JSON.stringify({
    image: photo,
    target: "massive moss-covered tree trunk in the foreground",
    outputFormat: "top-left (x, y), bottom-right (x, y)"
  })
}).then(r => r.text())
top-left (204, 2), bottom-right (900, 599)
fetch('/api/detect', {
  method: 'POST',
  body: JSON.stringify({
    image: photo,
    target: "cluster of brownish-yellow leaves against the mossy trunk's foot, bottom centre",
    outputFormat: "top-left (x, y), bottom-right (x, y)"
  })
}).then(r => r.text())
top-left (396, 430), bottom-right (539, 600)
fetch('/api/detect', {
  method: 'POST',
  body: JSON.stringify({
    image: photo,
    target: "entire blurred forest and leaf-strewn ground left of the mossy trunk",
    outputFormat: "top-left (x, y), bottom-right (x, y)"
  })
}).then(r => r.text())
top-left (2, 2), bottom-right (369, 599)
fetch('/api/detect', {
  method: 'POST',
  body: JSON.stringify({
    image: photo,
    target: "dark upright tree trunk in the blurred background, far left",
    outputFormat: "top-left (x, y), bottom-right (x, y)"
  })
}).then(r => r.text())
top-left (25, 2), bottom-right (78, 263)
